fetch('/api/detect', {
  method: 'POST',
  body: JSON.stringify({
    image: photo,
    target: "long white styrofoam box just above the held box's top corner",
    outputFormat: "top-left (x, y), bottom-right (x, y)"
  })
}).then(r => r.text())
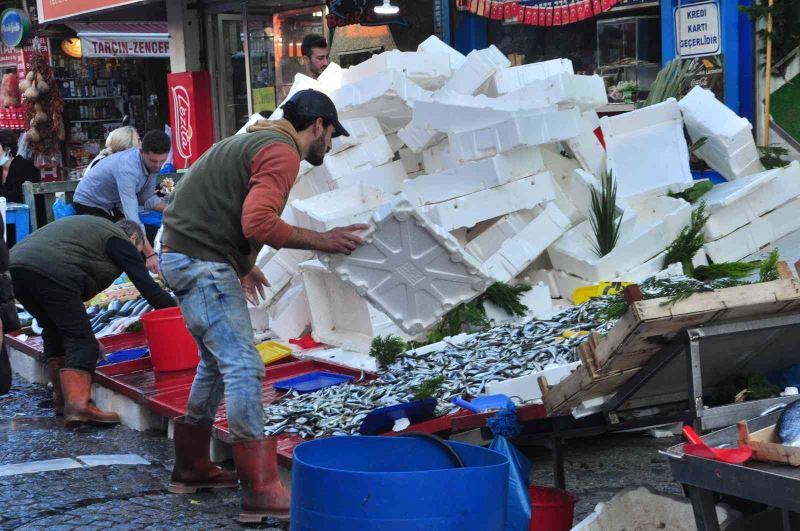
top-left (403, 146), bottom-right (544, 206)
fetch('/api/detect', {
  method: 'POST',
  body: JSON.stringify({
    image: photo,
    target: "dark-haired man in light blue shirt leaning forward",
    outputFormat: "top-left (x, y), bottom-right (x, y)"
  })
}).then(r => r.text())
top-left (72, 130), bottom-right (170, 273)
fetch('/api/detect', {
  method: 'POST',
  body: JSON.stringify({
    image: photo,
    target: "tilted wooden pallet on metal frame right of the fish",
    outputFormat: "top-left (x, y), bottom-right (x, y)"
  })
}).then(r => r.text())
top-left (543, 279), bottom-right (800, 414)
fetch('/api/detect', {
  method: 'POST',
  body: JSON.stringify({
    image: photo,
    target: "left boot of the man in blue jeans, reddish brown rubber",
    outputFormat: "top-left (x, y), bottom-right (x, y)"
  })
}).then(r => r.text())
top-left (168, 417), bottom-right (239, 494)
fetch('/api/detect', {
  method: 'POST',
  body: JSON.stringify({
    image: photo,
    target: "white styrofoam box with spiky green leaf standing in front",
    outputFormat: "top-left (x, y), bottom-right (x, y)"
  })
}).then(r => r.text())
top-left (548, 196), bottom-right (691, 286)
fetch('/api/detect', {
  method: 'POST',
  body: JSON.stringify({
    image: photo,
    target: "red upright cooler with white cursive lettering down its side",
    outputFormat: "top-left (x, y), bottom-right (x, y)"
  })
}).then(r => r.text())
top-left (167, 72), bottom-right (214, 170)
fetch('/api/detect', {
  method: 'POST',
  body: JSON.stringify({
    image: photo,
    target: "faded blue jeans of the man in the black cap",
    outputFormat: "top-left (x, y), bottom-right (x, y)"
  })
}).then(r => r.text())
top-left (159, 252), bottom-right (264, 440)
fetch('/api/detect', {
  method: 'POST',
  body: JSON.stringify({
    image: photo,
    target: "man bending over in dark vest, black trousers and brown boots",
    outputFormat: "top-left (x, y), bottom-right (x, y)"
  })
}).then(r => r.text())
top-left (10, 216), bottom-right (175, 428)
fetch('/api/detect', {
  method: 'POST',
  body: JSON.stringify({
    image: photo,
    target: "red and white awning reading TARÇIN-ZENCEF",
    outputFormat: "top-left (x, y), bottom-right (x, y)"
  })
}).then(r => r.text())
top-left (67, 22), bottom-right (169, 59)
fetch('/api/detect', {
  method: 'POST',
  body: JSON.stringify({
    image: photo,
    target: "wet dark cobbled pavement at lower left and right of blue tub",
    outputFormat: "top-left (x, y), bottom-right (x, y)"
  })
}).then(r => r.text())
top-left (0, 379), bottom-right (680, 531)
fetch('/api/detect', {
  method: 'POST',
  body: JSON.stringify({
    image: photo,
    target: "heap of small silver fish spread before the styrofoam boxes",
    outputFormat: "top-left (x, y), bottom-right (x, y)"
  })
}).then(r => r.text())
top-left (264, 297), bottom-right (616, 438)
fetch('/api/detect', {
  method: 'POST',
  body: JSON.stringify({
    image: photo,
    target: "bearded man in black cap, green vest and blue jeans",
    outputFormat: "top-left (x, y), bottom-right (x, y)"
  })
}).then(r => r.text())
top-left (160, 90), bottom-right (367, 522)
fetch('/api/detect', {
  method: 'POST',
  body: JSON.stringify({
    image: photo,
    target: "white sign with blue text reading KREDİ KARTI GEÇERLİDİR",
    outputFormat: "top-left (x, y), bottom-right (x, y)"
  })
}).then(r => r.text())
top-left (674, 2), bottom-right (722, 57)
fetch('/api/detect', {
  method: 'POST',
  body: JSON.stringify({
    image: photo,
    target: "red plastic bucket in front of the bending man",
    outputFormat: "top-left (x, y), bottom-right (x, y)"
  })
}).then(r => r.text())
top-left (140, 306), bottom-right (200, 372)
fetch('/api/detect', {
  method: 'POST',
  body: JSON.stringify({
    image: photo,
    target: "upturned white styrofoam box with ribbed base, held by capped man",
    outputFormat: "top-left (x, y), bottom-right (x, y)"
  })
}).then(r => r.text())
top-left (320, 196), bottom-right (492, 334)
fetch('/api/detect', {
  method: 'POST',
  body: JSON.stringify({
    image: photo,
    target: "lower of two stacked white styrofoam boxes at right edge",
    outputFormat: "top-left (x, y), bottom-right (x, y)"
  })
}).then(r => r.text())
top-left (705, 198), bottom-right (800, 263)
